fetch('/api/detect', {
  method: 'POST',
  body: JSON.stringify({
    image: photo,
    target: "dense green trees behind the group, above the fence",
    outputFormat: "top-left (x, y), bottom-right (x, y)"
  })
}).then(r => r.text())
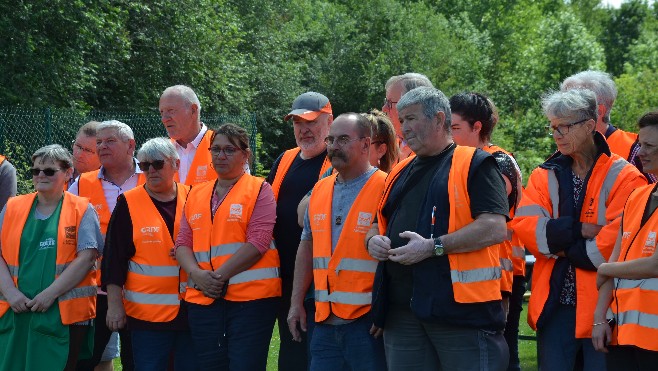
top-left (0, 0), bottom-right (658, 179)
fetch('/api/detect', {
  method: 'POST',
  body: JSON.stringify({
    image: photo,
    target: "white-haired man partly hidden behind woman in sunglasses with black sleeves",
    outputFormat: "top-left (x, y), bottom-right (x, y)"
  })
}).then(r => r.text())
top-left (69, 120), bottom-right (145, 370)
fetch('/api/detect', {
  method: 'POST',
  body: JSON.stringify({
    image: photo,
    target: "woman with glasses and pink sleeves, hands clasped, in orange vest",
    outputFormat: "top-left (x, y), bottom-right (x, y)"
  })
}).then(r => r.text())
top-left (176, 124), bottom-right (281, 370)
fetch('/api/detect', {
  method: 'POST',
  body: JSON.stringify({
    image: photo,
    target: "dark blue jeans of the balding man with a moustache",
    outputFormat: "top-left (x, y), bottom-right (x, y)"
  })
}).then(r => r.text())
top-left (311, 315), bottom-right (386, 371)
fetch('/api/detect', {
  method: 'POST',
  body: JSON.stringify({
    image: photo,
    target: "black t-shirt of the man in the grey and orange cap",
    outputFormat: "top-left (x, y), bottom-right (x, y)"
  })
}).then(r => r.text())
top-left (267, 151), bottom-right (327, 279)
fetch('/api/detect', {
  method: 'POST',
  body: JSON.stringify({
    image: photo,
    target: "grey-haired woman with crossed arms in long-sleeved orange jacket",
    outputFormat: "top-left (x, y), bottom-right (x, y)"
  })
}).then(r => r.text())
top-left (512, 89), bottom-right (646, 370)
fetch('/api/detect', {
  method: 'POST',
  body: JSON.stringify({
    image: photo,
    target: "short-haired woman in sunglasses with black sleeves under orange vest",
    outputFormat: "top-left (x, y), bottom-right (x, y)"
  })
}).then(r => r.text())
top-left (102, 138), bottom-right (196, 370)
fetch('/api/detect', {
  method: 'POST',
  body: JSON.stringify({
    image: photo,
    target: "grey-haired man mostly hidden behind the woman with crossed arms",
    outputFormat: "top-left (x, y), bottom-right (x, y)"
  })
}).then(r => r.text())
top-left (560, 70), bottom-right (657, 183)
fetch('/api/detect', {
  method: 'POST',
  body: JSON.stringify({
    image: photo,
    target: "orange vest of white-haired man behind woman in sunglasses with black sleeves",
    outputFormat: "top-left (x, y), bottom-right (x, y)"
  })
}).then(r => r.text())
top-left (78, 169), bottom-right (146, 285)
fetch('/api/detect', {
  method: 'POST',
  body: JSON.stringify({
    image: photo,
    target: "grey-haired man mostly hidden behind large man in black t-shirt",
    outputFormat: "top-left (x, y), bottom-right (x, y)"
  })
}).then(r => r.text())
top-left (382, 72), bottom-right (434, 161)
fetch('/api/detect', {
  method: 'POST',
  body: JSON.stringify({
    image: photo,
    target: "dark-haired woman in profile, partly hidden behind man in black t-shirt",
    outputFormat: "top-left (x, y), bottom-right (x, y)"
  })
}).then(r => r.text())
top-left (450, 93), bottom-right (525, 370)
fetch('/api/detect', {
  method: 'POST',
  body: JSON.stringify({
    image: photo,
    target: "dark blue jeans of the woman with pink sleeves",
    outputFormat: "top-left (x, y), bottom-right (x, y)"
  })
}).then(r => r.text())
top-left (188, 298), bottom-right (279, 371)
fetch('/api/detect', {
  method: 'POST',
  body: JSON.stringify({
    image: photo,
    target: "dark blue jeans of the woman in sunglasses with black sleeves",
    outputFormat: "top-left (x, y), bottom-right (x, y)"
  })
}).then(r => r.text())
top-left (131, 330), bottom-right (199, 371)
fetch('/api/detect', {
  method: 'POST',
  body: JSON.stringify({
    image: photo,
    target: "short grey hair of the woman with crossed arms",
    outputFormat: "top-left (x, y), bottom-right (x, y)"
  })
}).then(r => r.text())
top-left (542, 89), bottom-right (597, 121)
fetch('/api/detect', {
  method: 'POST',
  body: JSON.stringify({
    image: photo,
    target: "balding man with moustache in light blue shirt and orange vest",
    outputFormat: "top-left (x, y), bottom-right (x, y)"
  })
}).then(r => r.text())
top-left (288, 113), bottom-right (386, 370)
